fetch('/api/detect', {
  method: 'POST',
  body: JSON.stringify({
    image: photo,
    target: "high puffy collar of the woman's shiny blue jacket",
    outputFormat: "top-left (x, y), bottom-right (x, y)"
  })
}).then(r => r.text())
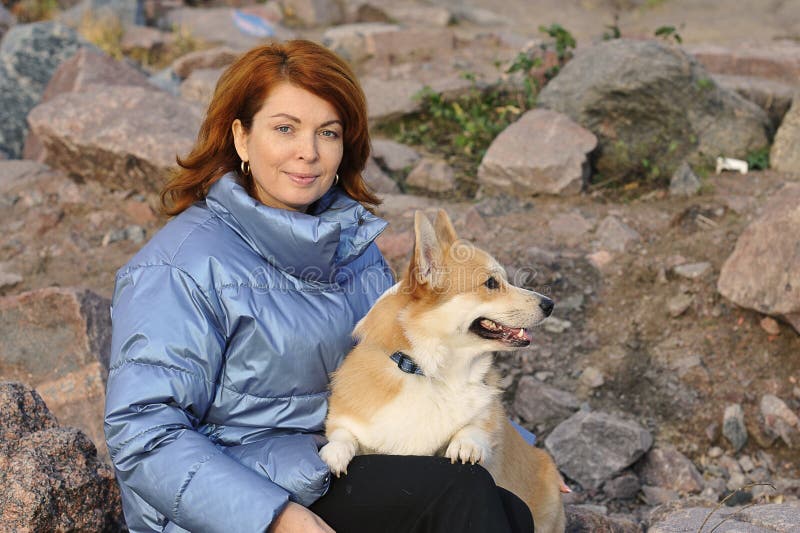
top-left (206, 172), bottom-right (387, 282)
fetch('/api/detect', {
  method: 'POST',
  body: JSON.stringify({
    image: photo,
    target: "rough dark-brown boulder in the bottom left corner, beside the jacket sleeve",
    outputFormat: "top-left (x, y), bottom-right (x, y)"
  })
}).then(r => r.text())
top-left (0, 381), bottom-right (124, 532)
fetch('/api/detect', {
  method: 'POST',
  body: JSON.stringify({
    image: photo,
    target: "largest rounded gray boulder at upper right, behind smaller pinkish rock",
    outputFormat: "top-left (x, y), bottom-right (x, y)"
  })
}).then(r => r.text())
top-left (538, 39), bottom-right (770, 184)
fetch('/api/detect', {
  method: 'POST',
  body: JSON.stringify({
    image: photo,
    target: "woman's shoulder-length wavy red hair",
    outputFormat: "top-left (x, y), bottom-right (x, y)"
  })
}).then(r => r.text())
top-left (161, 40), bottom-right (381, 215)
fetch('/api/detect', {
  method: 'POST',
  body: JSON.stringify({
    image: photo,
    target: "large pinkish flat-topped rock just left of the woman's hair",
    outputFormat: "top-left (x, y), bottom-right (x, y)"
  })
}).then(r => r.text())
top-left (28, 83), bottom-right (202, 191)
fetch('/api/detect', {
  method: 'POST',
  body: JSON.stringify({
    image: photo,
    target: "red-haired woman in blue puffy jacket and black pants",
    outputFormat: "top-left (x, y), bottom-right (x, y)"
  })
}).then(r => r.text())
top-left (105, 41), bottom-right (532, 533)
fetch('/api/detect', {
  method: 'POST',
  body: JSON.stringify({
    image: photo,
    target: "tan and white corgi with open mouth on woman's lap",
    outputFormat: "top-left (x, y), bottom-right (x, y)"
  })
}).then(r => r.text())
top-left (319, 210), bottom-right (569, 533)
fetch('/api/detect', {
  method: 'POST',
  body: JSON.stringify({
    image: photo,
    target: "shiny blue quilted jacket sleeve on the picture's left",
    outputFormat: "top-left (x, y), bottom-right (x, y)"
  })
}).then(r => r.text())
top-left (105, 265), bottom-right (288, 533)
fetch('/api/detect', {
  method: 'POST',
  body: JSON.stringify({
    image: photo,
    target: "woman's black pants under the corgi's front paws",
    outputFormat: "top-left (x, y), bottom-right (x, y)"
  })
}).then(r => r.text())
top-left (310, 455), bottom-right (533, 533)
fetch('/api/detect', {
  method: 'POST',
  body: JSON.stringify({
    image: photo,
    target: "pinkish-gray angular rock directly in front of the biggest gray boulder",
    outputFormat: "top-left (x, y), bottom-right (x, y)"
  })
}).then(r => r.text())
top-left (478, 109), bottom-right (597, 196)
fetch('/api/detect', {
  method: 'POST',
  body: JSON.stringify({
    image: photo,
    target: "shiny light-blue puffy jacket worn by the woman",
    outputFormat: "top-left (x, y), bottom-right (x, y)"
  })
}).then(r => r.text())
top-left (105, 175), bottom-right (393, 533)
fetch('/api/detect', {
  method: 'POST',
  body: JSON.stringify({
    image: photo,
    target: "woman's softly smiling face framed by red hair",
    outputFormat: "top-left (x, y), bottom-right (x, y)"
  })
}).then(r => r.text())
top-left (232, 82), bottom-right (344, 211)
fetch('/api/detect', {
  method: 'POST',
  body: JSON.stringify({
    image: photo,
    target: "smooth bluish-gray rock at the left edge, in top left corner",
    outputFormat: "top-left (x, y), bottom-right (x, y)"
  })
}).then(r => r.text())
top-left (0, 22), bottom-right (86, 158)
